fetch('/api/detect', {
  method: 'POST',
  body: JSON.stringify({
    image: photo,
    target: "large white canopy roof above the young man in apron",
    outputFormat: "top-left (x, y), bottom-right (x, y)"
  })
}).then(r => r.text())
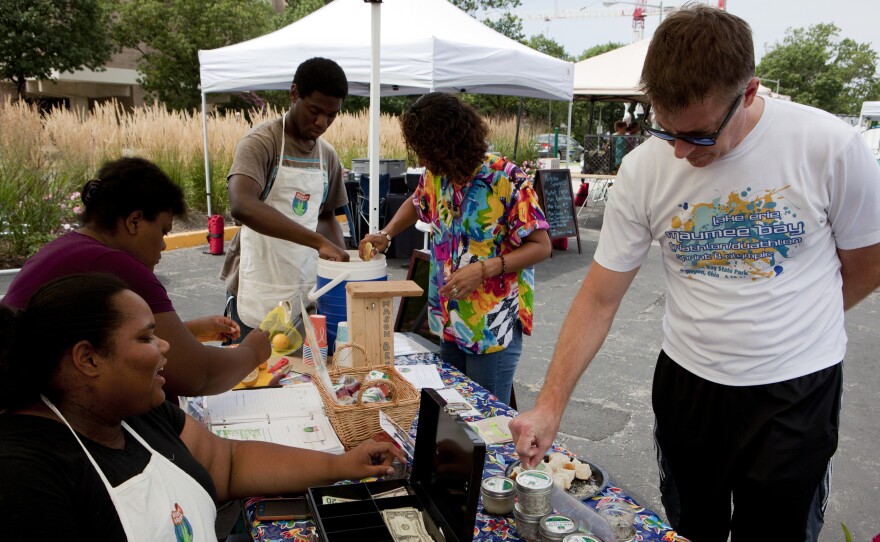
top-left (199, 0), bottom-right (574, 101)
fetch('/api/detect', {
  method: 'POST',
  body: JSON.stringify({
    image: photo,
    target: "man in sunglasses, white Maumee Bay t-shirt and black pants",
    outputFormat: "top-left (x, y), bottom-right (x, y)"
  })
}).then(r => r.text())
top-left (511, 5), bottom-right (880, 542)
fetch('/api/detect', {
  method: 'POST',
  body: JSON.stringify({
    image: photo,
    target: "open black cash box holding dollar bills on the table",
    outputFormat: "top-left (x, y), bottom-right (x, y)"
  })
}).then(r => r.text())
top-left (306, 389), bottom-right (486, 542)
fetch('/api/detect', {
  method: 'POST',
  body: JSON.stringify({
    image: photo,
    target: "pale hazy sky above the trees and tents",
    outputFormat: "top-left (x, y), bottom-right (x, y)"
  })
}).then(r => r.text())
top-left (488, 0), bottom-right (880, 61)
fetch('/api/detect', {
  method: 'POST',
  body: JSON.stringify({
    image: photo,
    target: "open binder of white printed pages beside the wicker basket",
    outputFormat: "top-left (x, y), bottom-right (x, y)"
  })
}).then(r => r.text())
top-left (205, 384), bottom-right (345, 454)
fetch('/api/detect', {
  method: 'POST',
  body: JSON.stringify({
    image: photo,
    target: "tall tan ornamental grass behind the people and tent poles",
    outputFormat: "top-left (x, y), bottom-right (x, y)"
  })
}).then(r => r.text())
top-left (0, 98), bottom-right (534, 266)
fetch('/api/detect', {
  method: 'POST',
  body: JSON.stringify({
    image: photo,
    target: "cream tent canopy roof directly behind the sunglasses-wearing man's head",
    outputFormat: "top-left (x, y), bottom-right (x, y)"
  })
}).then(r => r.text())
top-left (574, 39), bottom-right (651, 101)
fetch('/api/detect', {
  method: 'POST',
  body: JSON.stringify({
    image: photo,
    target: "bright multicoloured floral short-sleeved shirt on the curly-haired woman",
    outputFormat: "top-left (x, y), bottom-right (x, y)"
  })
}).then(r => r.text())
top-left (413, 154), bottom-right (549, 354)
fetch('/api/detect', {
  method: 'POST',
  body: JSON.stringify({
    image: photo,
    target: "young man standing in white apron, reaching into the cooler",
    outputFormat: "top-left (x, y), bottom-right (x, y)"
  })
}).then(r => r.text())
top-left (220, 58), bottom-right (348, 337)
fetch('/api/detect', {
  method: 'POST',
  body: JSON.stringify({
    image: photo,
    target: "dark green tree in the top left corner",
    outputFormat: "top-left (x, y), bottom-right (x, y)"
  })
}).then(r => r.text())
top-left (0, 0), bottom-right (113, 97)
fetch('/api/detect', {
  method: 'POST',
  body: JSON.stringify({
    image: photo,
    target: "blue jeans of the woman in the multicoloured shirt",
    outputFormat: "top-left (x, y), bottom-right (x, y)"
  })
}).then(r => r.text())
top-left (440, 322), bottom-right (522, 404)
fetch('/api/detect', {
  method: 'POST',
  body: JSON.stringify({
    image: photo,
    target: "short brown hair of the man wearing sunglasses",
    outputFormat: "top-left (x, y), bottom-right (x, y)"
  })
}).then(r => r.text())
top-left (640, 4), bottom-right (755, 114)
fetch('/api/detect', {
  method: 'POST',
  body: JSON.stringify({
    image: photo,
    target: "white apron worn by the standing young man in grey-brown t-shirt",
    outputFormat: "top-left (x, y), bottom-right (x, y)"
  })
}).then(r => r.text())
top-left (236, 115), bottom-right (327, 328)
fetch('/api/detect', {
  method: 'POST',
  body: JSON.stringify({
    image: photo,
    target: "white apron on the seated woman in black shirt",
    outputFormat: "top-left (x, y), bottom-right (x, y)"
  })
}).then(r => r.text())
top-left (42, 397), bottom-right (217, 542)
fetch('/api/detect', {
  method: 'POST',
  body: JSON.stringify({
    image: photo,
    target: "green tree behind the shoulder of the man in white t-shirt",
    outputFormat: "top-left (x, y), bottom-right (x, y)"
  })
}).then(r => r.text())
top-left (757, 23), bottom-right (880, 115)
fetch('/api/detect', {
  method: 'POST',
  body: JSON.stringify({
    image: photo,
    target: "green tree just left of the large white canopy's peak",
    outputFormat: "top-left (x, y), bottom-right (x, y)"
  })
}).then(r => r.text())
top-left (113, 0), bottom-right (275, 109)
